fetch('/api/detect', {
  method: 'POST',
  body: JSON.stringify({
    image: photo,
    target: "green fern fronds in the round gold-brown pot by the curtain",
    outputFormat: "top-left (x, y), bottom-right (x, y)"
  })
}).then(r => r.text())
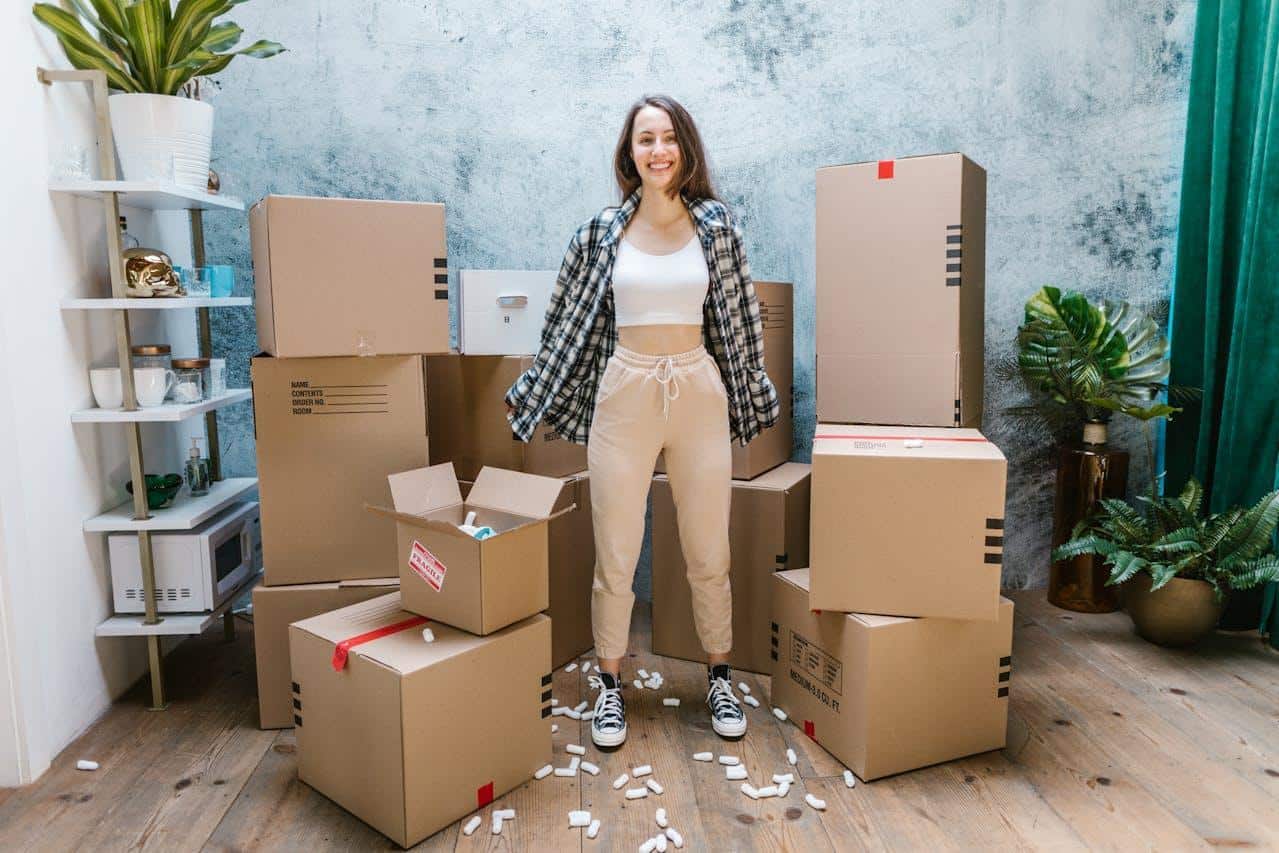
top-left (1053, 477), bottom-right (1279, 601)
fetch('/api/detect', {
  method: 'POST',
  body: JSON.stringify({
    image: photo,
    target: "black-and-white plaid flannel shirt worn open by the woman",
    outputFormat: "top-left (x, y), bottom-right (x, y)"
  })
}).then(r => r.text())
top-left (505, 189), bottom-right (781, 445)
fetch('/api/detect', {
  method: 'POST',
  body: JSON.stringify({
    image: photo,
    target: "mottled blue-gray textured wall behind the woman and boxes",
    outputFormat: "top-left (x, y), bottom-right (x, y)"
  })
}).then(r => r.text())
top-left (207, 0), bottom-right (1195, 587)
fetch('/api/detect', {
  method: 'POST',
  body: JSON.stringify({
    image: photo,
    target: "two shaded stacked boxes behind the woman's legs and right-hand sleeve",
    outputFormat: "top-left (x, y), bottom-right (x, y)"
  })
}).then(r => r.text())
top-left (650, 281), bottom-right (808, 673)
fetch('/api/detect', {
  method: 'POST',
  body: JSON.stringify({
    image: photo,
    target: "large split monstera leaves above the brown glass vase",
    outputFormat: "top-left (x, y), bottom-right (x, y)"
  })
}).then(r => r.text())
top-left (1017, 286), bottom-right (1182, 423)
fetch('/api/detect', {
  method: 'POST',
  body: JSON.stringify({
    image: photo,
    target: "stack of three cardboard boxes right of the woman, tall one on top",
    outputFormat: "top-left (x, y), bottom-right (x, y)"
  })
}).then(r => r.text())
top-left (770, 153), bottom-right (1012, 779)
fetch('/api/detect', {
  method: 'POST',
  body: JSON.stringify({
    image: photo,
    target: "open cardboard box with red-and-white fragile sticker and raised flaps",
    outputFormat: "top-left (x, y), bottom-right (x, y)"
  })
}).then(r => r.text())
top-left (367, 462), bottom-right (572, 634)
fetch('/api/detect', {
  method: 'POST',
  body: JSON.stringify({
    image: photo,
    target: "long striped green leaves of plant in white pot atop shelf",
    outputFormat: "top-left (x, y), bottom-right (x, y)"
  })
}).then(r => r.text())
top-left (32, 0), bottom-right (284, 95)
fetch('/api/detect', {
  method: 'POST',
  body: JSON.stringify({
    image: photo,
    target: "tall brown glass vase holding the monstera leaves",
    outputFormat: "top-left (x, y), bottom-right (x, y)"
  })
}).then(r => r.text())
top-left (1048, 423), bottom-right (1128, 613)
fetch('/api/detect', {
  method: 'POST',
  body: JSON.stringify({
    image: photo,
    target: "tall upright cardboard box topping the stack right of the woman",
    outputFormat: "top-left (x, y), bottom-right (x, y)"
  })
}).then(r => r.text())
top-left (817, 153), bottom-right (986, 428)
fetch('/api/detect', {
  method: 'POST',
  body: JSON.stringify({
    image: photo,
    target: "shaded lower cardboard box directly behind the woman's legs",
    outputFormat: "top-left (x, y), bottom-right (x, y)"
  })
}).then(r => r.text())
top-left (652, 462), bottom-right (810, 673)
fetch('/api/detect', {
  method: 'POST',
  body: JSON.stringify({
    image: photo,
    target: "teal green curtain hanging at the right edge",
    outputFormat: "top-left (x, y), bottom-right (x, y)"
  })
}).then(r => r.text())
top-left (1166, 0), bottom-right (1279, 647)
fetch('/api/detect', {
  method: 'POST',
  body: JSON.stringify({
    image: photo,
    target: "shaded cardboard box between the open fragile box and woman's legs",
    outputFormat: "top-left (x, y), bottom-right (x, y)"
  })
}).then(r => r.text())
top-left (459, 471), bottom-right (596, 666)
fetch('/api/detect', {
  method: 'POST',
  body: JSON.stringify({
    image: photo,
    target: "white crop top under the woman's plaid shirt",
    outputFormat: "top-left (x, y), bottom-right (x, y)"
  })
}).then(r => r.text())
top-left (613, 233), bottom-right (711, 326)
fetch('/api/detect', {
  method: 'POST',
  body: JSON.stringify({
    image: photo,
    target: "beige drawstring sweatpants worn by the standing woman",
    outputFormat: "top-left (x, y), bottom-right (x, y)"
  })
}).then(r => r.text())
top-left (586, 347), bottom-right (733, 659)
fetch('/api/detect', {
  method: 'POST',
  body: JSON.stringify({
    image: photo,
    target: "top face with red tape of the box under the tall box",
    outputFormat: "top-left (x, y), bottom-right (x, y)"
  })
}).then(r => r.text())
top-left (812, 423), bottom-right (1004, 462)
